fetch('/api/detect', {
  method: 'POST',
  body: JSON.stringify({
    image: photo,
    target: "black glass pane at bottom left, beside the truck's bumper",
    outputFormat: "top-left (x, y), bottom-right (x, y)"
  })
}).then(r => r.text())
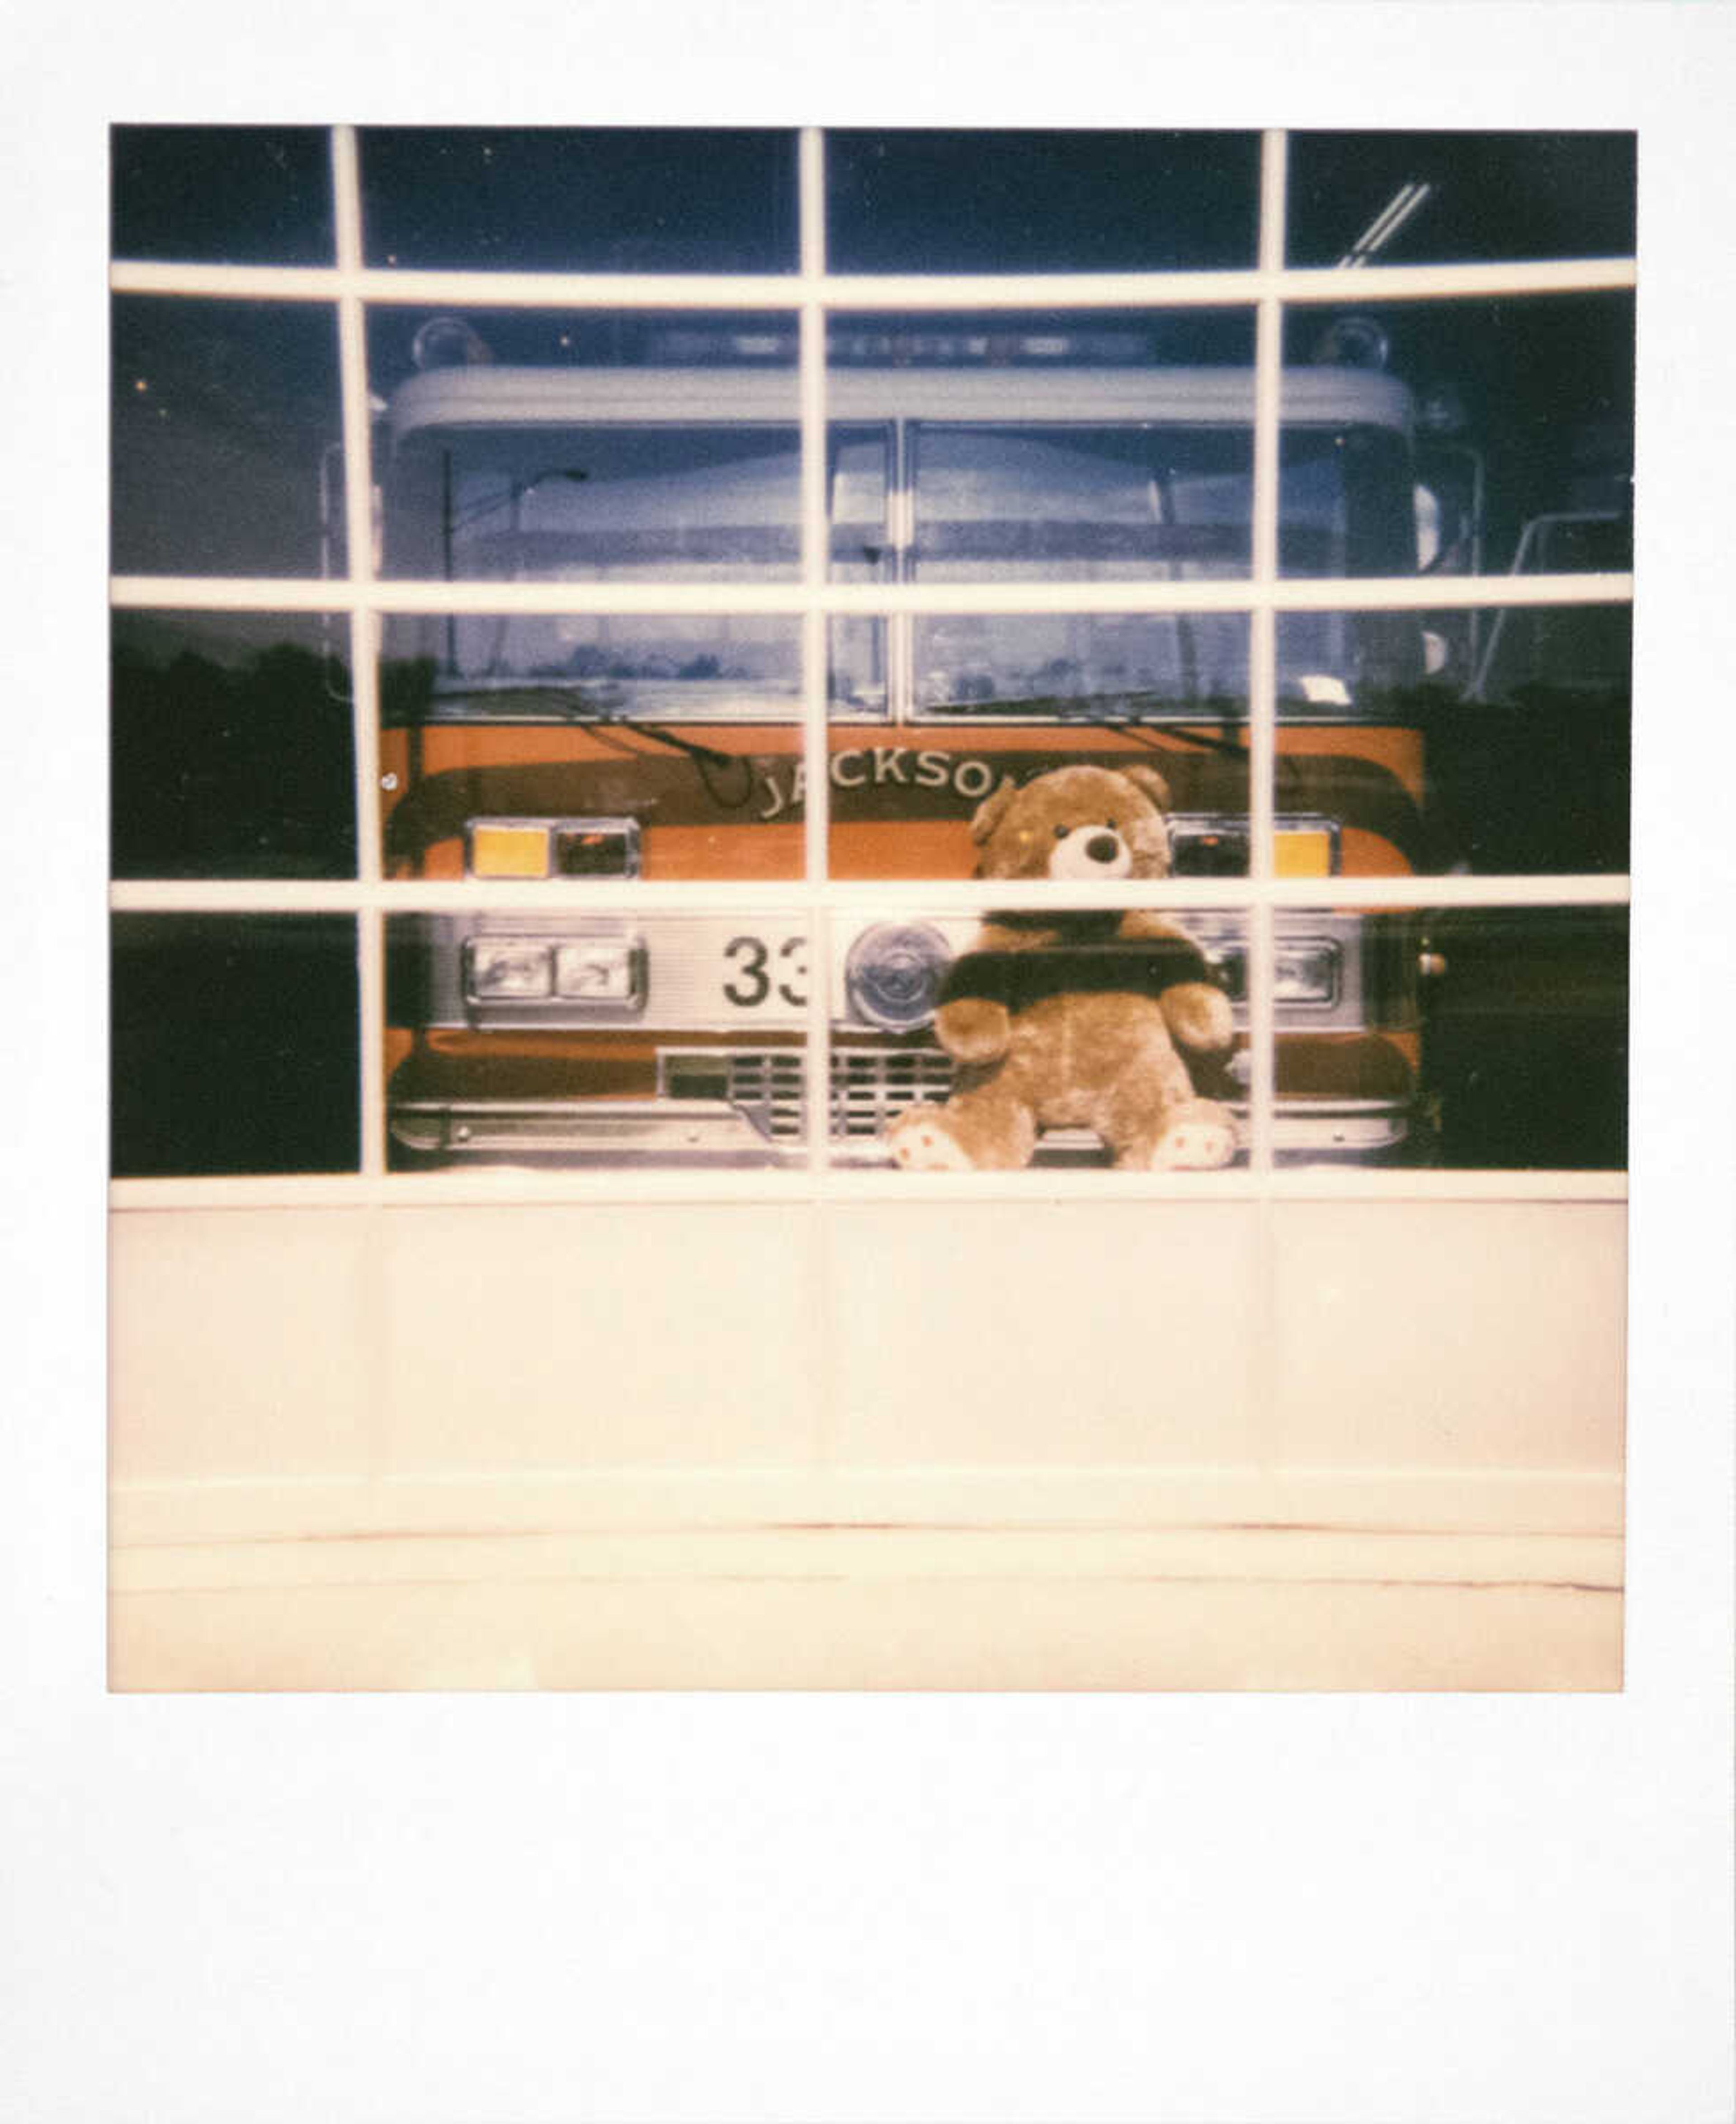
top-left (110, 913), bottom-right (361, 1179)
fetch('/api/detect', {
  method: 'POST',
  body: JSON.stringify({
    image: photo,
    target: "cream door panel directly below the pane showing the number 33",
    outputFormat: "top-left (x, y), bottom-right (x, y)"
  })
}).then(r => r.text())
top-left (380, 1202), bottom-right (815, 1476)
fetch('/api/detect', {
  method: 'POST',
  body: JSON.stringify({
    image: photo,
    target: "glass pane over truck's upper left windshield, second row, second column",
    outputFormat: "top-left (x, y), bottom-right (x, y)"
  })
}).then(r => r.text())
top-left (369, 310), bottom-right (800, 582)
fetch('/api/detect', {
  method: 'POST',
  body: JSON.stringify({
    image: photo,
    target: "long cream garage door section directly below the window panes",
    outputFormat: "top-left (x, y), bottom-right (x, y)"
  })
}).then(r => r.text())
top-left (113, 1200), bottom-right (1626, 1538)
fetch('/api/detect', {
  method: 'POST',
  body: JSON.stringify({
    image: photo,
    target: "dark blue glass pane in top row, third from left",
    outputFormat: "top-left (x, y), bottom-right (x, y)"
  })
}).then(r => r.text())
top-left (826, 130), bottom-right (1260, 272)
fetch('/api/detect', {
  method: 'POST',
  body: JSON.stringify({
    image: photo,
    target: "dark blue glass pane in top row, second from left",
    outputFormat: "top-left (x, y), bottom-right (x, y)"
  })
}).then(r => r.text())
top-left (361, 125), bottom-right (796, 272)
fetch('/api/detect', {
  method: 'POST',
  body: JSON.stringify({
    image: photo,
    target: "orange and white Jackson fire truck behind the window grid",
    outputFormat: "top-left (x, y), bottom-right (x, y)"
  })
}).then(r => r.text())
top-left (376, 319), bottom-right (1483, 1168)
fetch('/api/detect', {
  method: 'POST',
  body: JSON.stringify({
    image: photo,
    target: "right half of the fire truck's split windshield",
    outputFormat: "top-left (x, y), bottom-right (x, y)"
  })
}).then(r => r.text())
top-left (910, 425), bottom-right (1415, 720)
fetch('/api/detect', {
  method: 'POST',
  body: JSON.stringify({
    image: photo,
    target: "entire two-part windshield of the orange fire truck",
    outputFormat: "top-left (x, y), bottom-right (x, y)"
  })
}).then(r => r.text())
top-left (384, 406), bottom-right (1415, 720)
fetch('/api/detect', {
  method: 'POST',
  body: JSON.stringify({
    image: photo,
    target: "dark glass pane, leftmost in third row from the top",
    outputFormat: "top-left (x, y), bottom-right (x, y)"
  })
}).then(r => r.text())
top-left (110, 612), bottom-right (357, 877)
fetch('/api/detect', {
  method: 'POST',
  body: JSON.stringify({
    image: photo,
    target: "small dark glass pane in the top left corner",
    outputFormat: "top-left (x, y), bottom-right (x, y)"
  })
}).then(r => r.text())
top-left (110, 125), bottom-right (333, 265)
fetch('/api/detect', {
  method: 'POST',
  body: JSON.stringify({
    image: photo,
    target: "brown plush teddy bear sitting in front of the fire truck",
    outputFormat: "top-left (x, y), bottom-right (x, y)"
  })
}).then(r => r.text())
top-left (885, 765), bottom-right (1235, 1173)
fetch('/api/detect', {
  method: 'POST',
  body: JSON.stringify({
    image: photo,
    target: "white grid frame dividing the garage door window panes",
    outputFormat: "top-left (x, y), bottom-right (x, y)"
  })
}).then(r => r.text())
top-left (108, 125), bottom-right (1636, 1209)
